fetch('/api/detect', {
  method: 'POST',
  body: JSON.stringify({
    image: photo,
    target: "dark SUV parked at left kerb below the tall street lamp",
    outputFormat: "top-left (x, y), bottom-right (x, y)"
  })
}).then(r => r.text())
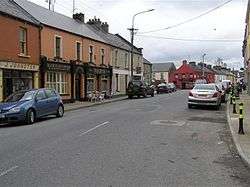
top-left (126, 80), bottom-right (154, 99)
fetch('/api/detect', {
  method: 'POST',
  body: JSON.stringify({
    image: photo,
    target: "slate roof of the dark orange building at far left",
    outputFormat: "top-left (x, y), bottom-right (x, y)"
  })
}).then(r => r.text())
top-left (0, 0), bottom-right (40, 25)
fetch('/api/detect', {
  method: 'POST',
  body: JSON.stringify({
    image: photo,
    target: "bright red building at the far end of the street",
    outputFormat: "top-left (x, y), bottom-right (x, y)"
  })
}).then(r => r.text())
top-left (170, 60), bottom-right (215, 89)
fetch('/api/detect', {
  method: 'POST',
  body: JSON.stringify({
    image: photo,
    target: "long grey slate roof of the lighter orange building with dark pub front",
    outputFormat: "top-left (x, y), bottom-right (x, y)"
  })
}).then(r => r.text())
top-left (14, 0), bottom-right (105, 43)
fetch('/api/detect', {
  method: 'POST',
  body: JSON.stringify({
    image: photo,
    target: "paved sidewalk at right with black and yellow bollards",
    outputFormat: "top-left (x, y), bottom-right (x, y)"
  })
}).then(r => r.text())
top-left (227, 93), bottom-right (250, 167)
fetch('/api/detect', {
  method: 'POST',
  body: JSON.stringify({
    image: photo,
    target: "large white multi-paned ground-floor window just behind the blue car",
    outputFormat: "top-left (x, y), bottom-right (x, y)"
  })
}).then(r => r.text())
top-left (46, 72), bottom-right (68, 94)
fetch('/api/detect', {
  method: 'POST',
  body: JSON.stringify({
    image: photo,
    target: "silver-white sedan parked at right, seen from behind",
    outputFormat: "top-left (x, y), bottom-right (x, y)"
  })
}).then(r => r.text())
top-left (188, 84), bottom-right (221, 109)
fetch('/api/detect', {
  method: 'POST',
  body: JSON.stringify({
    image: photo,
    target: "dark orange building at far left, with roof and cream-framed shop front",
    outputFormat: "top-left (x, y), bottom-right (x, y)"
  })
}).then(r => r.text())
top-left (0, 0), bottom-right (40, 101)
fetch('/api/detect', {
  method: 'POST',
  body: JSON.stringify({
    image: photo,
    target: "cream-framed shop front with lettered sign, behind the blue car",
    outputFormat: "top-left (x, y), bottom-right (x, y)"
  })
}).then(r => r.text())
top-left (0, 62), bottom-right (39, 101)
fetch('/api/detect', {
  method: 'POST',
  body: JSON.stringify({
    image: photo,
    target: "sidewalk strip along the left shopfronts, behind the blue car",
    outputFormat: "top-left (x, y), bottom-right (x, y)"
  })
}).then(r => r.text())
top-left (64, 96), bottom-right (128, 112)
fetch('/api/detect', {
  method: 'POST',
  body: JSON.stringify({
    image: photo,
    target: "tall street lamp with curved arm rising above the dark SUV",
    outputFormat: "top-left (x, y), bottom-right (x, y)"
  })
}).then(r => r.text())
top-left (128, 9), bottom-right (155, 80)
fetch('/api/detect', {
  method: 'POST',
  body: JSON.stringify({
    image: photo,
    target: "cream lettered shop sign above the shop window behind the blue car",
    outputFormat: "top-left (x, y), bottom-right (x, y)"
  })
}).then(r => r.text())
top-left (0, 62), bottom-right (39, 71)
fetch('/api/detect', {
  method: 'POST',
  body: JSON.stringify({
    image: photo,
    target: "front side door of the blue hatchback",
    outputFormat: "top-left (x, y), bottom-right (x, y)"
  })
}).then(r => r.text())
top-left (35, 90), bottom-right (49, 117)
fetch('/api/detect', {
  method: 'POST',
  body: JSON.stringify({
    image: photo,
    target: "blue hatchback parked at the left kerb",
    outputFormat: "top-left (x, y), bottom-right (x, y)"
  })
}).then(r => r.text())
top-left (0, 88), bottom-right (64, 124)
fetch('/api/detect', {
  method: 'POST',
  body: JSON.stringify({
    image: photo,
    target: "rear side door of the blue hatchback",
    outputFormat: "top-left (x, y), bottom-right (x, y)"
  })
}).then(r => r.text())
top-left (45, 89), bottom-right (58, 114)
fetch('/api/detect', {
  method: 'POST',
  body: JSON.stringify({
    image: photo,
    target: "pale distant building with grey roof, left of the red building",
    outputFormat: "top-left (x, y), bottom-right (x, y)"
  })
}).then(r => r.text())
top-left (152, 62), bottom-right (176, 83)
